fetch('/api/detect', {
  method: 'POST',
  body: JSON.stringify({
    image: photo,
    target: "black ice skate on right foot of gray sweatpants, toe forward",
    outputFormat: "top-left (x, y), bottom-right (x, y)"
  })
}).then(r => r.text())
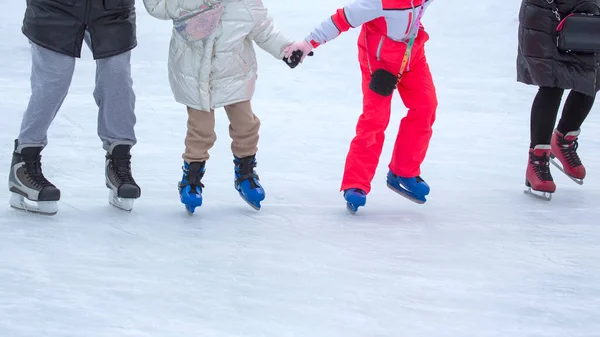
top-left (105, 144), bottom-right (141, 211)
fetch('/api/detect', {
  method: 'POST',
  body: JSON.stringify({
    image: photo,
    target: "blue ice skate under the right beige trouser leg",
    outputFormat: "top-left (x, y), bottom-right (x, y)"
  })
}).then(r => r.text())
top-left (233, 156), bottom-right (265, 211)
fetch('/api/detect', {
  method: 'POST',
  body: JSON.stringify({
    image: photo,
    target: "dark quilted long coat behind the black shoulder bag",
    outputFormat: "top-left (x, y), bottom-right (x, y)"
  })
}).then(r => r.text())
top-left (517, 0), bottom-right (600, 96)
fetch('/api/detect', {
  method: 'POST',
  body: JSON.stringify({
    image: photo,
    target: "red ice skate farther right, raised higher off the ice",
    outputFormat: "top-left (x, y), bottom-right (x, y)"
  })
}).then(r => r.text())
top-left (550, 130), bottom-right (585, 185)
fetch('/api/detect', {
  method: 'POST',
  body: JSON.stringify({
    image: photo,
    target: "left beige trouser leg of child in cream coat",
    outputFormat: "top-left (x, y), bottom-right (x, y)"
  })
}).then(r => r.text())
top-left (183, 107), bottom-right (217, 164)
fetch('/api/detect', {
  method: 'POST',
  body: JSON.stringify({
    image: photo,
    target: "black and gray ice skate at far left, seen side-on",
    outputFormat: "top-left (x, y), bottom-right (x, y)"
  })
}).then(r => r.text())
top-left (8, 140), bottom-right (60, 215)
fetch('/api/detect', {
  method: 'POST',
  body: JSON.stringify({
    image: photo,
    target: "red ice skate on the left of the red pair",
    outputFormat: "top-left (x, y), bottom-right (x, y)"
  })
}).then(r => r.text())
top-left (524, 145), bottom-right (556, 201)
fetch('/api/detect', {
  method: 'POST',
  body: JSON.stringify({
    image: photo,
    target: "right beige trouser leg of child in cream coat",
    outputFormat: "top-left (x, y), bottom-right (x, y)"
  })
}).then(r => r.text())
top-left (225, 101), bottom-right (260, 158)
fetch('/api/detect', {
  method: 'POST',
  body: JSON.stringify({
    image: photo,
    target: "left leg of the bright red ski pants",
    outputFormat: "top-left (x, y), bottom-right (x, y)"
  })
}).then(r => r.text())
top-left (341, 64), bottom-right (392, 193)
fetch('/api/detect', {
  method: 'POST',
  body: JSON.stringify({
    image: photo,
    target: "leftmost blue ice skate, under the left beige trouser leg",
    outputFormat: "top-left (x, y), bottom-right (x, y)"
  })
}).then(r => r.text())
top-left (178, 162), bottom-right (205, 215)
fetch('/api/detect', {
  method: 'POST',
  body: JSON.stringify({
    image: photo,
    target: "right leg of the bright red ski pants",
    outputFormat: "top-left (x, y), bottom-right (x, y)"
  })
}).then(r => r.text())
top-left (389, 49), bottom-right (438, 178)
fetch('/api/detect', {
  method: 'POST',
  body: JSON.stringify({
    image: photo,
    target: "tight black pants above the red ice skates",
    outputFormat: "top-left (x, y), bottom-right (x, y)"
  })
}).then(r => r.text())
top-left (530, 87), bottom-right (596, 148)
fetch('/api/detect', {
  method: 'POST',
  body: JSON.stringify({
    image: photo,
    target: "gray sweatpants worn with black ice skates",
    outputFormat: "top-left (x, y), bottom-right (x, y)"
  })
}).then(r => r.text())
top-left (19, 42), bottom-right (137, 150)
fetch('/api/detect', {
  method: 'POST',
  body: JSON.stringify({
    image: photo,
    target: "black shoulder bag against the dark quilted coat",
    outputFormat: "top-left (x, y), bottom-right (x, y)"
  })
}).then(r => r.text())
top-left (546, 0), bottom-right (600, 54)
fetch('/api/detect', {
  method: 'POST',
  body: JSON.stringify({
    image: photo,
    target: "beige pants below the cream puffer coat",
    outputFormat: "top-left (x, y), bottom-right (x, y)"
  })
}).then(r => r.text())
top-left (183, 101), bottom-right (260, 164)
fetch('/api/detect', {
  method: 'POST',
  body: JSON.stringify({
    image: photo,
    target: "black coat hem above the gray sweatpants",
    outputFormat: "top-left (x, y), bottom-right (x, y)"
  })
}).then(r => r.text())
top-left (22, 0), bottom-right (137, 59)
